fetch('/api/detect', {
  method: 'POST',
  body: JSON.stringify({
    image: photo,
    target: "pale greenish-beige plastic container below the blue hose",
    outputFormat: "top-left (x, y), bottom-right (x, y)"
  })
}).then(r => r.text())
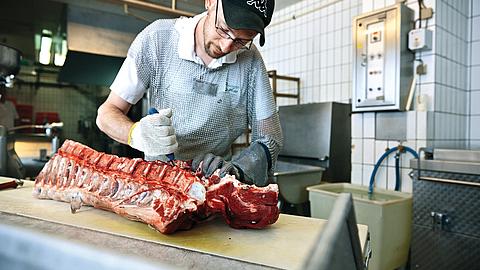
top-left (307, 183), bottom-right (412, 270)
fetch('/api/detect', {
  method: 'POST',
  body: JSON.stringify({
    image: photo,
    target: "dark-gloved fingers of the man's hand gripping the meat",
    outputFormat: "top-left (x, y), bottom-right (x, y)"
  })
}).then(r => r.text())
top-left (192, 153), bottom-right (242, 181)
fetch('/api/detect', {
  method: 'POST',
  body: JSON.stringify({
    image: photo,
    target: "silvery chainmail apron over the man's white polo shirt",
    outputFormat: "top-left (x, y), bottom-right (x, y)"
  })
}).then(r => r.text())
top-left (129, 20), bottom-right (282, 171)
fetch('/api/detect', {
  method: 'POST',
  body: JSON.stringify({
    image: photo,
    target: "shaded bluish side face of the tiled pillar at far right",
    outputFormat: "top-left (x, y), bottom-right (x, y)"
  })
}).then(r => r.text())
top-left (432, 0), bottom-right (471, 148)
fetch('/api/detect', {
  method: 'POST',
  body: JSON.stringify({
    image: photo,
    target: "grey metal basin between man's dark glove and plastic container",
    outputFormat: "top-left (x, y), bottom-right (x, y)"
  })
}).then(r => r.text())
top-left (273, 161), bottom-right (325, 204)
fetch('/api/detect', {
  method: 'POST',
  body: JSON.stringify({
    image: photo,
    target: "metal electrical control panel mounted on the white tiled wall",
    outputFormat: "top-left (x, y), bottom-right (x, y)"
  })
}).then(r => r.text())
top-left (352, 4), bottom-right (414, 112)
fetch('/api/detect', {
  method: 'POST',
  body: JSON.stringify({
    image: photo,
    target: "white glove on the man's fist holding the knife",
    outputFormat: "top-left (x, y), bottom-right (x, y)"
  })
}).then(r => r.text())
top-left (128, 108), bottom-right (178, 156)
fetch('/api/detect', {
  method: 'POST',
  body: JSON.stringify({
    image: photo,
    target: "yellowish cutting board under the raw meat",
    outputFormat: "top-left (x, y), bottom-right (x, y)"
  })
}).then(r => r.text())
top-left (0, 177), bottom-right (367, 269)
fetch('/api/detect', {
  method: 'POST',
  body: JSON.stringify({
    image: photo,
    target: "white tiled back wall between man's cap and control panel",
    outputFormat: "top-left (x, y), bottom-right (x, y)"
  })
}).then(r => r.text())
top-left (260, 0), bottom-right (361, 106)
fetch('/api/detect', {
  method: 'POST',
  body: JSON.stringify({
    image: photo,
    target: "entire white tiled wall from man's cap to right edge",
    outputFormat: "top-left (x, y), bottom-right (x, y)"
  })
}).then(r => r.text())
top-left (261, 0), bottom-right (480, 192)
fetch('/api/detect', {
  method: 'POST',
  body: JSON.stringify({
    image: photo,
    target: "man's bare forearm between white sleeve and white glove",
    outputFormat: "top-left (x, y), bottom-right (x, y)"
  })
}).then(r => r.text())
top-left (96, 104), bottom-right (133, 144)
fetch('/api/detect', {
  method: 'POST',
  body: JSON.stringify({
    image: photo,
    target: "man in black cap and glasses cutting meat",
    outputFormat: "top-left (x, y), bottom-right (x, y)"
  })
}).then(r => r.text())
top-left (97, 0), bottom-right (282, 186)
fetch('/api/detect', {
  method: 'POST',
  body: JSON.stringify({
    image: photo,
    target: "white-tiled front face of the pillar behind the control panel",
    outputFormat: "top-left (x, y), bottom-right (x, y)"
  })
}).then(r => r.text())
top-left (346, 0), bottom-right (438, 192)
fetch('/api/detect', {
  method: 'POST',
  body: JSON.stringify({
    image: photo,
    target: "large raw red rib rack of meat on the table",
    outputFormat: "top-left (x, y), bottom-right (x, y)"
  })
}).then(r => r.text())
top-left (33, 140), bottom-right (279, 233)
